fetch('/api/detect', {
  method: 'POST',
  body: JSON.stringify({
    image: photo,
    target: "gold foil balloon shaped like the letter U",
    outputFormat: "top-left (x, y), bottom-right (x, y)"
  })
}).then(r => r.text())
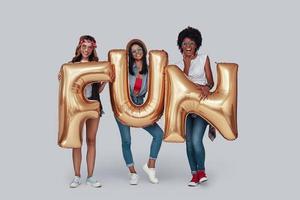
top-left (108, 50), bottom-right (168, 127)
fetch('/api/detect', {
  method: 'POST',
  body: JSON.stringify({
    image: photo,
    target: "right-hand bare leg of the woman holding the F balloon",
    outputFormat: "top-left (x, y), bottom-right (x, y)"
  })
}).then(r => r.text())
top-left (86, 118), bottom-right (100, 177)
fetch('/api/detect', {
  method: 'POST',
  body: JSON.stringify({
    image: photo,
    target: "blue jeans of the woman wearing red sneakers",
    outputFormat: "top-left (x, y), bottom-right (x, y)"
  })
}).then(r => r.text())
top-left (186, 114), bottom-right (208, 174)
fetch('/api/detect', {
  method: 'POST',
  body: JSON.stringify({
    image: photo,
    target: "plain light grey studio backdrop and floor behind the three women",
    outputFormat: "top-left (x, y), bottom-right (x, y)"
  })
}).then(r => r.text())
top-left (0, 0), bottom-right (300, 199)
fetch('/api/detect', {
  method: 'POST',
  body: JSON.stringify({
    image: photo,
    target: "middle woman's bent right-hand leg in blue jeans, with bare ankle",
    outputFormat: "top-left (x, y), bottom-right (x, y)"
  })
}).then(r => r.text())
top-left (144, 123), bottom-right (163, 168)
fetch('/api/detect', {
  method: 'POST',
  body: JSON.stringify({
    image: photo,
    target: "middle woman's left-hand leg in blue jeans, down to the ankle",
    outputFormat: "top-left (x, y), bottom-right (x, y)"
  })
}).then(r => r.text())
top-left (116, 118), bottom-right (136, 173)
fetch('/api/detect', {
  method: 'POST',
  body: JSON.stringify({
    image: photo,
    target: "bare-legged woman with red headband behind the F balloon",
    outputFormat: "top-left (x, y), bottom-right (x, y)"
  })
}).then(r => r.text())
top-left (58, 35), bottom-right (105, 188)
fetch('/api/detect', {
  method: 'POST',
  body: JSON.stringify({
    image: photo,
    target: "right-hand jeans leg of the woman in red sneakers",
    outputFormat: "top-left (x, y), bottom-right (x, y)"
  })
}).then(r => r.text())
top-left (192, 116), bottom-right (207, 170)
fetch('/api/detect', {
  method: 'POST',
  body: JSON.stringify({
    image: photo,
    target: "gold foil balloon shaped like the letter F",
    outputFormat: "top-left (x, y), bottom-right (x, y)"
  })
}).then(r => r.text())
top-left (58, 62), bottom-right (114, 148)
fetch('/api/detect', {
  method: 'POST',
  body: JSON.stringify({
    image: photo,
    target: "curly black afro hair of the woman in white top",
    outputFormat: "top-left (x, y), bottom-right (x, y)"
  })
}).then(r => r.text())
top-left (177, 26), bottom-right (202, 53)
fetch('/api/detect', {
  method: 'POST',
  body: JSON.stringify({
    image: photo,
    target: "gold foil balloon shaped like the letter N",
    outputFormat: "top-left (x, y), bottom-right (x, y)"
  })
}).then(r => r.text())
top-left (164, 63), bottom-right (238, 142)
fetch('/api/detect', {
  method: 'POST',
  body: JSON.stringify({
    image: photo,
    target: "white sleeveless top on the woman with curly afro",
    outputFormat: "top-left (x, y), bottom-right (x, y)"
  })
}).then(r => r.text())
top-left (176, 54), bottom-right (207, 85)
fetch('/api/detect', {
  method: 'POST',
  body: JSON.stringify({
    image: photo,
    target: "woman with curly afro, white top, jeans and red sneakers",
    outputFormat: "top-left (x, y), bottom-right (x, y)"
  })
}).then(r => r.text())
top-left (177, 27), bottom-right (215, 186)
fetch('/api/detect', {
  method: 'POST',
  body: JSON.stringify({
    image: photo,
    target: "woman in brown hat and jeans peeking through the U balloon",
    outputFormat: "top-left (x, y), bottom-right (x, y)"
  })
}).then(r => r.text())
top-left (116, 39), bottom-right (163, 185)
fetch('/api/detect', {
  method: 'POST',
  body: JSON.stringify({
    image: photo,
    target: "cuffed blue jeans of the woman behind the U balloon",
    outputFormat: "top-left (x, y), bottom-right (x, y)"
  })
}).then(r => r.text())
top-left (116, 118), bottom-right (163, 167)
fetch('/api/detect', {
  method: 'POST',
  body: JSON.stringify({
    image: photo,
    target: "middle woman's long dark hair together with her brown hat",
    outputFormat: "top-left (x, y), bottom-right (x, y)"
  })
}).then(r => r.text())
top-left (126, 39), bottom-right (148, 75)
